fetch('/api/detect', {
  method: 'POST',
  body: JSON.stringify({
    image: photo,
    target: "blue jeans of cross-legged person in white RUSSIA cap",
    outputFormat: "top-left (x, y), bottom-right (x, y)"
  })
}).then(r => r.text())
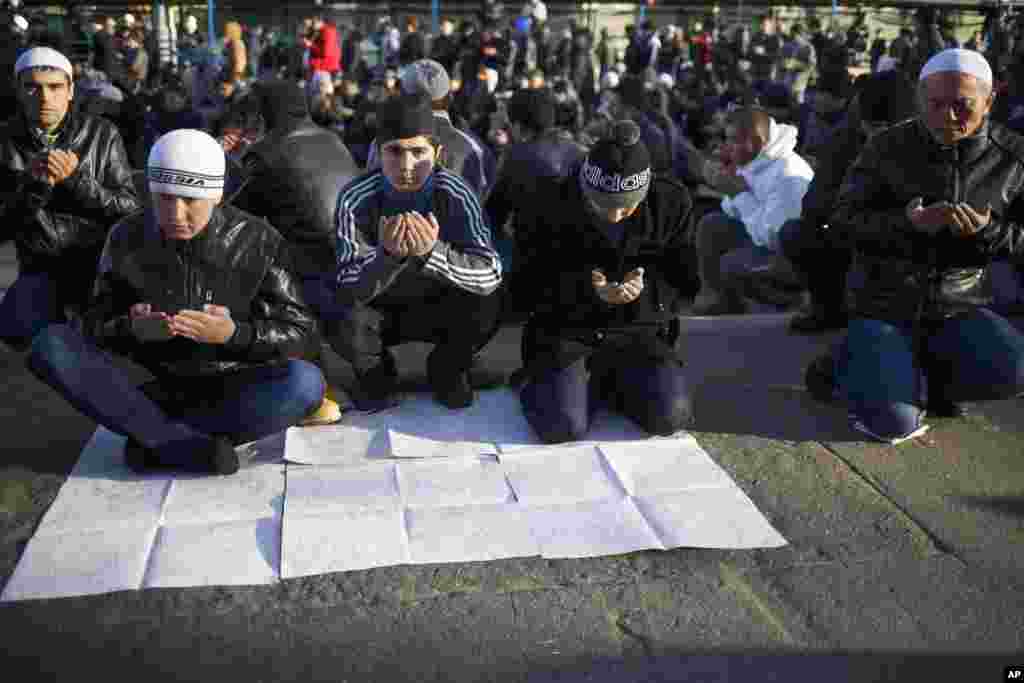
top-left (28, 325), bottom-right (326, 465)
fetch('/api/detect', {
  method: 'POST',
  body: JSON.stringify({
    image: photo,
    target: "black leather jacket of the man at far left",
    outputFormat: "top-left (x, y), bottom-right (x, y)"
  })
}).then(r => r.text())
top-left (0, 112), bottom-right (141, 272)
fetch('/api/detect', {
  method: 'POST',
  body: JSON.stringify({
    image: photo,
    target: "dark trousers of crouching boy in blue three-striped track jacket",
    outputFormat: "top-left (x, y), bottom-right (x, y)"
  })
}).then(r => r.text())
top-left (325, 283), bottom-right (502, 377)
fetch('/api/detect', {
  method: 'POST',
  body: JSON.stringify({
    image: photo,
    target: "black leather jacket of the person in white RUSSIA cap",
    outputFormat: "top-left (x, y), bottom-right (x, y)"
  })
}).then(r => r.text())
top-left (90, 206), bottom-right (315, 378)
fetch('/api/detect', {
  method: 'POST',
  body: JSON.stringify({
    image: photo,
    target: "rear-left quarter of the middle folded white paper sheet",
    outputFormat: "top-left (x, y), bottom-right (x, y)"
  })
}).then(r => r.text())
top-left (285, 462), bottom-right (401, 518)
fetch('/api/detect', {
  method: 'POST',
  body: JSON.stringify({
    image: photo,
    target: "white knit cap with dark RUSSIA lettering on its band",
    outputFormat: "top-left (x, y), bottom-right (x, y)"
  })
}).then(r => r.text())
top-left (145, 128), bottom-right (226, 200)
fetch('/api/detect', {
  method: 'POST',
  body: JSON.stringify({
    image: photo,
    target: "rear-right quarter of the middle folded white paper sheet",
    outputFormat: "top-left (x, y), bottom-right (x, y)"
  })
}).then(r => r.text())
top-left (397, 456), bottom-right (515, 508)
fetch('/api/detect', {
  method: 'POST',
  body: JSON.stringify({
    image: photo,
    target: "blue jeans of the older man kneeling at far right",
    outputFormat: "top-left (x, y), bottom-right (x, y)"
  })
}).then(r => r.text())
top-left (836, 308), bottom-right (1024, 438)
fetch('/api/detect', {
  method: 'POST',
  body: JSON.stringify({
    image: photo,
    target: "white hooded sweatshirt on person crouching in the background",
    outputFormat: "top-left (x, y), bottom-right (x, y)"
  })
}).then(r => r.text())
top-left (722, 119), bottom-right (814, 251)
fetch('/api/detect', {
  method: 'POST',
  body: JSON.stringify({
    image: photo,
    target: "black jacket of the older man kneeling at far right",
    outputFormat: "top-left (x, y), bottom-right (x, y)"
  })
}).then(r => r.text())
top-left (831, 119), bottom-right (1024, 322)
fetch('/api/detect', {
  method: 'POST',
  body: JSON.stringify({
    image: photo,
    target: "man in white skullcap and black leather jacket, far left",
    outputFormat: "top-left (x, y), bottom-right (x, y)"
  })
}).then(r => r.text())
top-left (0, 47), bottom-right (139, 350)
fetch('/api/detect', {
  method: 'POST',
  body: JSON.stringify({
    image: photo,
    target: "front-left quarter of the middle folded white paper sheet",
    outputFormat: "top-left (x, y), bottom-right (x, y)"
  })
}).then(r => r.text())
top-left (281, 506), bottom-right (410, 579)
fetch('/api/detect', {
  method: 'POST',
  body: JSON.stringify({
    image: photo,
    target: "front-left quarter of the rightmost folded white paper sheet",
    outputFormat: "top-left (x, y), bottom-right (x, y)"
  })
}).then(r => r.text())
top-left (526, 498), bottom-right (665, 558)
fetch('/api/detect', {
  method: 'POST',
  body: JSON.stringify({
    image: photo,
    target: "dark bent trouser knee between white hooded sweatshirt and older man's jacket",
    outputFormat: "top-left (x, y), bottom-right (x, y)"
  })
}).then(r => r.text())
top-left (778, 219), bottom-right (853, 312)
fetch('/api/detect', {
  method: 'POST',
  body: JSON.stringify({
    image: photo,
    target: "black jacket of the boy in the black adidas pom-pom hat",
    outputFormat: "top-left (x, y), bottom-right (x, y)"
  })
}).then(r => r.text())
top-left (516, 167), bottom-right (699, 374)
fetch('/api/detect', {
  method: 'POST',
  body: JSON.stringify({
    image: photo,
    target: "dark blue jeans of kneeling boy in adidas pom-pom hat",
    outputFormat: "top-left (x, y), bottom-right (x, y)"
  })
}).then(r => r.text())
top-left (519, 356), bottom-right (693, 443)
